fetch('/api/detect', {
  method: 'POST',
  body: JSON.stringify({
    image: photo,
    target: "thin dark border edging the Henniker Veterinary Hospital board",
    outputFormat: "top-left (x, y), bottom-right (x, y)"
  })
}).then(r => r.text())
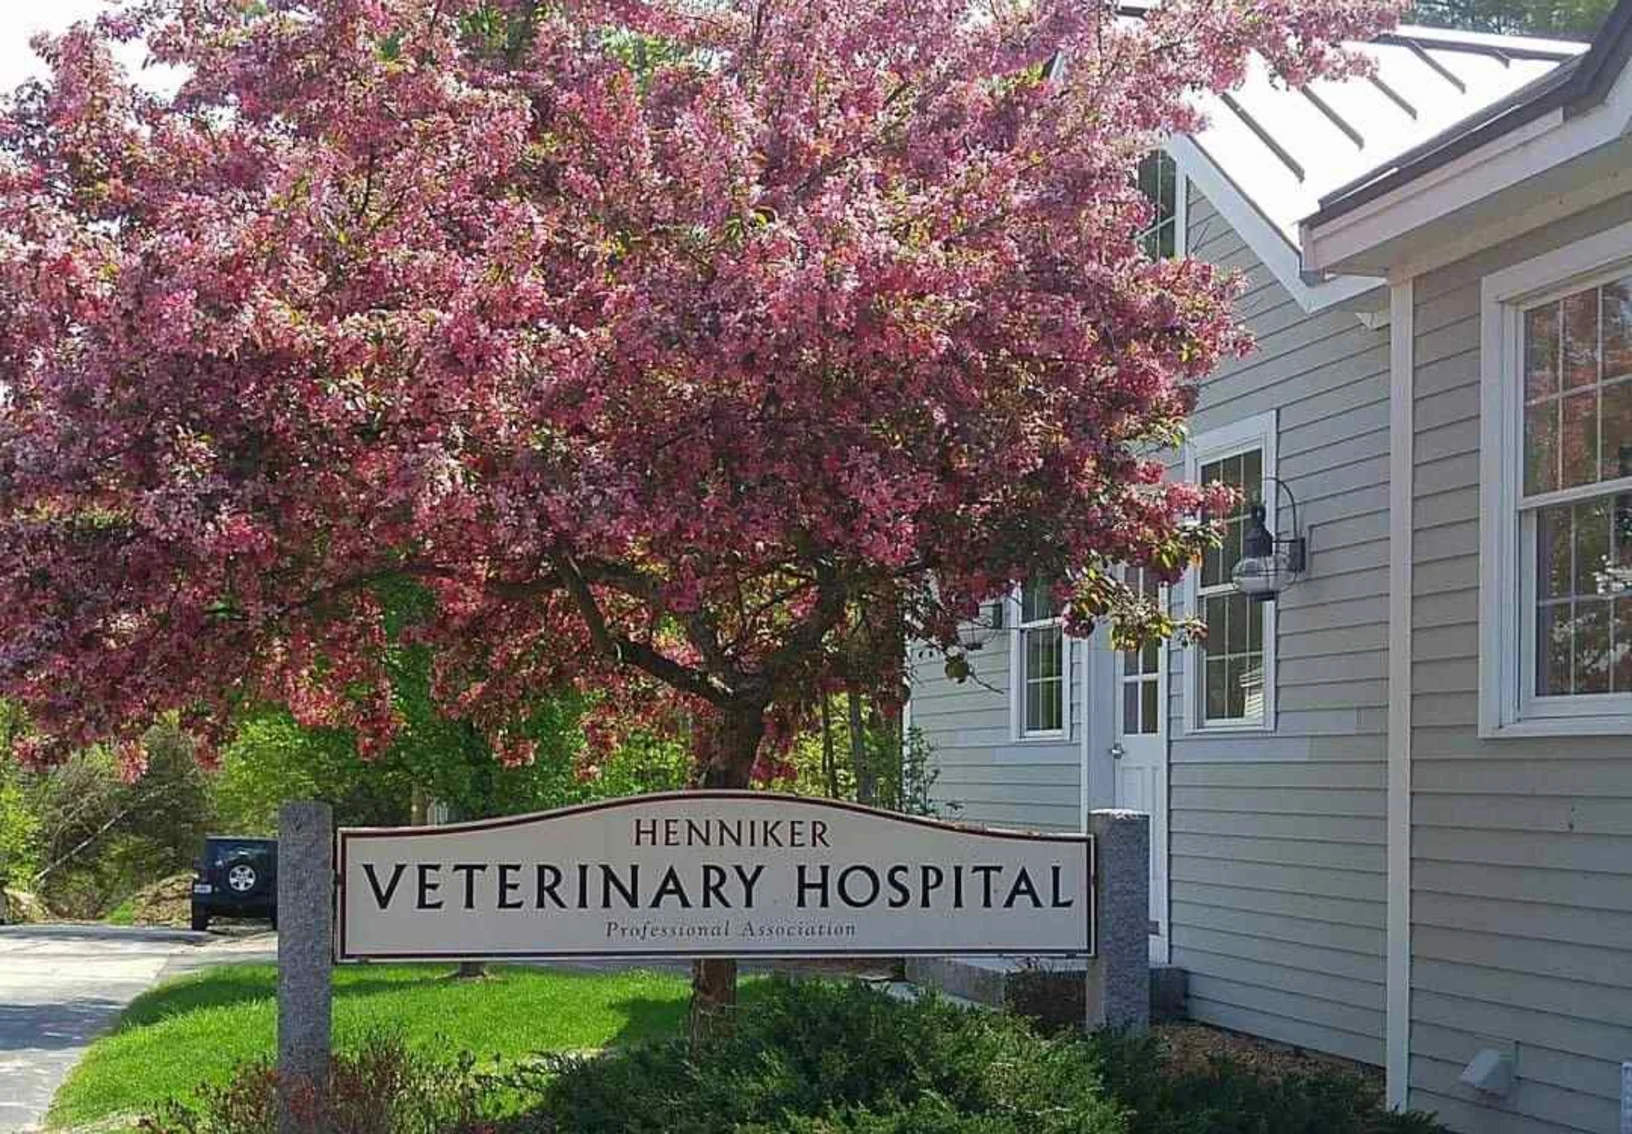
top-left (335, 788), bottom-right (1100, 964)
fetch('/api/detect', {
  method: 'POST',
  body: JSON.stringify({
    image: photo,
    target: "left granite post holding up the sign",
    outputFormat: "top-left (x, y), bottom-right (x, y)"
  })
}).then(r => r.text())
top-left (277, 803), bottom-right (335, 1134)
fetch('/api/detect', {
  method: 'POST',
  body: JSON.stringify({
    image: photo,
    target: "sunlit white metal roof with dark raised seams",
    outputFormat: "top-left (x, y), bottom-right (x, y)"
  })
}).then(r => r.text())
top-left (1191, 22), bottom-right (1586, 248)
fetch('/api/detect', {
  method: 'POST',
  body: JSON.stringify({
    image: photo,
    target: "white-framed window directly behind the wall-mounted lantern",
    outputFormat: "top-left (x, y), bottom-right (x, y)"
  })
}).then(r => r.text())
top-left (1185, 413), bottom-right (1276, 729)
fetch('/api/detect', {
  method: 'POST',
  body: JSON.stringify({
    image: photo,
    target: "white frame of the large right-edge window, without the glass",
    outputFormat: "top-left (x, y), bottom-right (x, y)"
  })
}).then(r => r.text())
top-left (1479, 224), bottom-right (1632, 738)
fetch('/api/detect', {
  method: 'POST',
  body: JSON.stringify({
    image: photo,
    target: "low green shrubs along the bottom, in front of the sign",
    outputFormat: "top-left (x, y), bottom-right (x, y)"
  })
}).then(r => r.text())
top-left (133, 979), bottom-right (1443, 1134)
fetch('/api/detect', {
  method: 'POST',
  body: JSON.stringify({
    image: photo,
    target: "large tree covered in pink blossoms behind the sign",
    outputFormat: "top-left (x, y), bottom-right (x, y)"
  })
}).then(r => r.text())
top-left (0, 0), bottom-right (1394, 999)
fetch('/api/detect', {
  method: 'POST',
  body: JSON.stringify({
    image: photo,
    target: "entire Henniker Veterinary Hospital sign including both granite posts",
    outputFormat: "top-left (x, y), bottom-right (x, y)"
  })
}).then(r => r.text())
top-left (277, 791), bottom-right (1151, 1134)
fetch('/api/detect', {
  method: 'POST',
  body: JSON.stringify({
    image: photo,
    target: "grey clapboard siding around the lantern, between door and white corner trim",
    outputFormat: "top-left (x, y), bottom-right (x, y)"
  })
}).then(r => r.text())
top-left (1170, 189), bottom-right (1389, 1064)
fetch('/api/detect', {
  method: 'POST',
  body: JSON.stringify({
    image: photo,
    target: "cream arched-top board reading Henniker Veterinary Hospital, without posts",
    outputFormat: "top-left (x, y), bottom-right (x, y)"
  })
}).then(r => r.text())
top-left (335, 791), bottom-right (1095, 961)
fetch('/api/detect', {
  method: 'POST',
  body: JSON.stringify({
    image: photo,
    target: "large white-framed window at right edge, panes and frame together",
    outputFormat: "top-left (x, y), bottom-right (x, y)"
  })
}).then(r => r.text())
top-left (1480, 232), bottom-right (1632, 734)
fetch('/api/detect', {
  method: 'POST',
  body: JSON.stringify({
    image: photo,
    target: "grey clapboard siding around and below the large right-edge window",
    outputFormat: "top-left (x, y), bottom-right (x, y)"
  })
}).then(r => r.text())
top-left (1410, 190), bottom-right (1632, 1134)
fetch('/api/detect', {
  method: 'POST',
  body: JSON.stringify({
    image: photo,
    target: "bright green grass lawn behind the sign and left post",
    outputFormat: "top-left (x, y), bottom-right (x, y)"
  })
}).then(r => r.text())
top-left (47, 964), bottom-right (714, 1127)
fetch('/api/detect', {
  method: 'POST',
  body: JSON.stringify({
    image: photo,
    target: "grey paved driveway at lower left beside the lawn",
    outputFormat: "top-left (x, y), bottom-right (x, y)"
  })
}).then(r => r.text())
top-left (0, 925), bottom-right (259, 1132)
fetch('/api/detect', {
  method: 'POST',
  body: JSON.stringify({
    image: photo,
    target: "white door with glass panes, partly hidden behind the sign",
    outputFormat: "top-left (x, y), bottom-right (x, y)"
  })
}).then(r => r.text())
top-left (1111, 569), bottom-right (1169, 964)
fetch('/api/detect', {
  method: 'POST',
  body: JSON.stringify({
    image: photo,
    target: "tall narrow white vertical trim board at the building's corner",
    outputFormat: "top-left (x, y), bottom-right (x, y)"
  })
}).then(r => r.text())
top-left (1384, 279), bottom-right (1417, 1110)
